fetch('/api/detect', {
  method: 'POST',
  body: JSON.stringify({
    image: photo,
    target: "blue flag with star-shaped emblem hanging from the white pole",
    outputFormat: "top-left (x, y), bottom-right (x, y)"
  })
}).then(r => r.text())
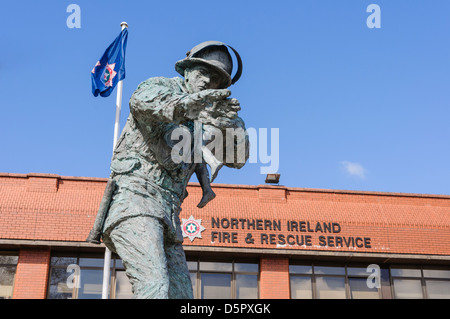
top-left (91, 28), bottom-right (128, 97)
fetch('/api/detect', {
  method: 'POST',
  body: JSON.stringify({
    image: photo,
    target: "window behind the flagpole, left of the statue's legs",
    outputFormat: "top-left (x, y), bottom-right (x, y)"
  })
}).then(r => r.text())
top-left (47, 254), bottom-right (132, 299)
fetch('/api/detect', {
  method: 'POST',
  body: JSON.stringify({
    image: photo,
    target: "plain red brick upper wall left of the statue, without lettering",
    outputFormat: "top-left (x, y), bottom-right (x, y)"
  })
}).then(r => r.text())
top-left (0, 173), bottom-right (106, 241)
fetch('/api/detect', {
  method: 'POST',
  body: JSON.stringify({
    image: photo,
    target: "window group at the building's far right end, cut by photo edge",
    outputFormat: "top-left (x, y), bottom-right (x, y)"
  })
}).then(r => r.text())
top-left (391, 267), bottom-right (450, 299)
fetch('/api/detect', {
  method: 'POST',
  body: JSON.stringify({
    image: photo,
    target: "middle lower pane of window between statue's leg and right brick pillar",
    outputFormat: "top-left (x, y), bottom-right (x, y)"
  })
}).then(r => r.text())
top-left (201, 274), bottom-right (231, 299)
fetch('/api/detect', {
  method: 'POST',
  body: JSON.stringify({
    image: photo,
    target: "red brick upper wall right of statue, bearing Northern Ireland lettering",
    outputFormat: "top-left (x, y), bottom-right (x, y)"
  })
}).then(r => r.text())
top-left (182, 185), bottom-right (450, 255)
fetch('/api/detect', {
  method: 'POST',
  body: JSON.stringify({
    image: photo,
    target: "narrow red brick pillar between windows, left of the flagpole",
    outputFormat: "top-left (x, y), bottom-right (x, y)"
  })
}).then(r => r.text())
top-left (13, 248), bottom-right (50, 299)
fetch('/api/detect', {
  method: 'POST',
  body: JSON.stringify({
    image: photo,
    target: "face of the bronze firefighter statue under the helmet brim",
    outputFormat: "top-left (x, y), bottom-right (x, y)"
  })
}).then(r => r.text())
top-left (184, 65), bottom-right (220, 93)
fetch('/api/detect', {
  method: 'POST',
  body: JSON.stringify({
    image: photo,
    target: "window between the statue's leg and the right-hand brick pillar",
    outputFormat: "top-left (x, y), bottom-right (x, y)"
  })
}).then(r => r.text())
top-left (188, 260), bottom-right (259, 299)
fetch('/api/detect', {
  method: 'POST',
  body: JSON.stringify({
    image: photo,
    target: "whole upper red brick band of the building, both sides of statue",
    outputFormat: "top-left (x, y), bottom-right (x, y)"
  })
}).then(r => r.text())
top-left (0, 173), bottom-right (450, 255)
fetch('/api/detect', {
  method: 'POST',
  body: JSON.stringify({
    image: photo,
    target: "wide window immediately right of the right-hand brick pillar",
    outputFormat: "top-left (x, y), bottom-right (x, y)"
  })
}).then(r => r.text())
top-left (289, 265), bottom-right (381, 299)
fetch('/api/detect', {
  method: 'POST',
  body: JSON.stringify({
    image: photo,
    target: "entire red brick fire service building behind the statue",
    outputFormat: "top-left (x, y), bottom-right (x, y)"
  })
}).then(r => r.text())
top-left (0, 173), bottom-right (450, 299)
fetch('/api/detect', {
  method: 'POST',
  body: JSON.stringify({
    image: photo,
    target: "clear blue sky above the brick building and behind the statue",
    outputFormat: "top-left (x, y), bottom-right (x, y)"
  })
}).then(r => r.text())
top-left (0, 0), bottom-right (450, 194)
